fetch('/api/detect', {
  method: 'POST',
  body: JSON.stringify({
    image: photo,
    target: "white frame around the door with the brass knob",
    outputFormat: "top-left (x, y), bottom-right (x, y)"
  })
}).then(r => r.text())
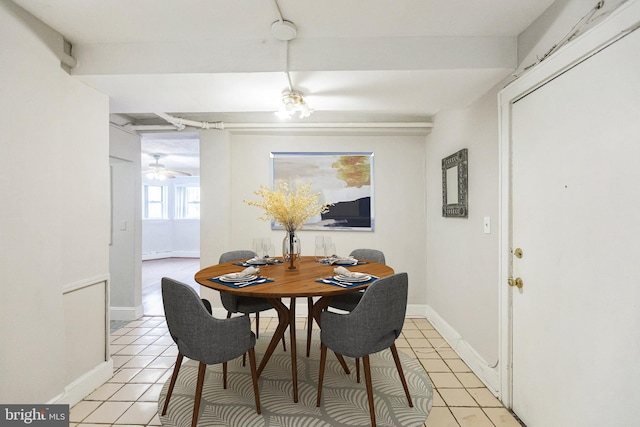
top-left (498, 1), bottom-right (640, 408)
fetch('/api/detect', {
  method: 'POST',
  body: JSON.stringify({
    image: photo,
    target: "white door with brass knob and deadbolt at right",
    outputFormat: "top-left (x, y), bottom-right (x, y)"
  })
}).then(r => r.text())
top-left (511, 27), bottom-right (640, 427)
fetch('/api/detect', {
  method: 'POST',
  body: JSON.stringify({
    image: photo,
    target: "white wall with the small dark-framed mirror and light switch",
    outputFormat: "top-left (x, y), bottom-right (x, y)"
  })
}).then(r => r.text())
top-left (426, 88), bottom-right (499, 391)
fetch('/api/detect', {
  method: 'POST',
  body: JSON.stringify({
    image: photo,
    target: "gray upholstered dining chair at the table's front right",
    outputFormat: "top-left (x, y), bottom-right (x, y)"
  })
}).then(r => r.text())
top-left (316, 273), bottom-right (413, 426)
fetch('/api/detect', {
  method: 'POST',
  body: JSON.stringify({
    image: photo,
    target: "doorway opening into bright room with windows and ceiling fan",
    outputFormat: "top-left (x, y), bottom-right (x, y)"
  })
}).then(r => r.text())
top-left (141, 133), bottom-right (200, 316)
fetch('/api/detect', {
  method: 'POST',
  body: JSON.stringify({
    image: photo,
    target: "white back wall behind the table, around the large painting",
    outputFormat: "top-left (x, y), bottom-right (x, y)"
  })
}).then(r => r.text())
top-left (200, 131), bottom-right (426, 315)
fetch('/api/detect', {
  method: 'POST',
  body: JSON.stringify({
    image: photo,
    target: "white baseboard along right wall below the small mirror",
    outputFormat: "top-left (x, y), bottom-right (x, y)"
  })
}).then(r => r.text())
top-left (426, 305), bottom-right (500, 396)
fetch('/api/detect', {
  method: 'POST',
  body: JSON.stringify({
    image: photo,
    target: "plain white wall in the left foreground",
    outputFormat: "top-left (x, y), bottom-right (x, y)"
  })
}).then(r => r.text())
top-left (0, 2), bottom-right (112, 403)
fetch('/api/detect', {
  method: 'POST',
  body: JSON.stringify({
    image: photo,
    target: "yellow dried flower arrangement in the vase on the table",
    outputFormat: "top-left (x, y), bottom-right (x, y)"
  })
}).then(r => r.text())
top-left (244, 180), bottom-right (332, 232)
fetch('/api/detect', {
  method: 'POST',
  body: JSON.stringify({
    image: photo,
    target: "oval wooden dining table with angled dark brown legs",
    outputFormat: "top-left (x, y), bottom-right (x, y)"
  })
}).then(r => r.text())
top-left (195, 256), bottom-right (394, 402)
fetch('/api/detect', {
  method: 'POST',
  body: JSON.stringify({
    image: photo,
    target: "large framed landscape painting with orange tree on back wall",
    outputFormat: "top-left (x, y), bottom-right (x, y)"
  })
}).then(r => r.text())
top-left (271, 152), bottom-right (375, 231)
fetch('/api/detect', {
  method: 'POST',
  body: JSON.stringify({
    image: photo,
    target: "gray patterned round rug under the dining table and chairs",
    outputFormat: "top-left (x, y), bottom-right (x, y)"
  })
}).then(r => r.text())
top-left (158, 331), bottom-right (433, 427)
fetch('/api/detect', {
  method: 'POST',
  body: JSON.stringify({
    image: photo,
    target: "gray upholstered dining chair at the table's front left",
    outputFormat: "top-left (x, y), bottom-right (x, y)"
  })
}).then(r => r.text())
top-left (162, 277), bottom-right (260, 427)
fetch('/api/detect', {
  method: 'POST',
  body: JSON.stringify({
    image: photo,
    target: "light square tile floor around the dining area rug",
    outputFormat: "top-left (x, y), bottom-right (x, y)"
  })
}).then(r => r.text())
top-left (70, 316), bottom-right (521, 427)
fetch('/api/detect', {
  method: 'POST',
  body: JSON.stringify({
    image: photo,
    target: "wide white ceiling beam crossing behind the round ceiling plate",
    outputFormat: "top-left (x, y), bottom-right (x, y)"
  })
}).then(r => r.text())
top-left (73, 37), bottom-right (517, 75)
